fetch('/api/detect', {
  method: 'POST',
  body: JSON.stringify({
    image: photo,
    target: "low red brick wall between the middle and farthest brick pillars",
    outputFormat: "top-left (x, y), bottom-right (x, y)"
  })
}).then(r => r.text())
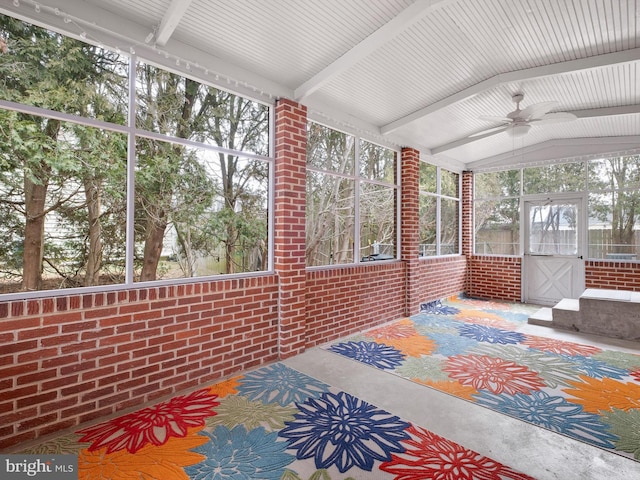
top-left (418, 257), bottom-right (467, 302)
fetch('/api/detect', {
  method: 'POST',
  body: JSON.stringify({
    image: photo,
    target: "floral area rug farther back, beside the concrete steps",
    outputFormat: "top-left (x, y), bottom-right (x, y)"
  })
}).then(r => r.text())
top-left (325, 297), bottom-right (640, 461)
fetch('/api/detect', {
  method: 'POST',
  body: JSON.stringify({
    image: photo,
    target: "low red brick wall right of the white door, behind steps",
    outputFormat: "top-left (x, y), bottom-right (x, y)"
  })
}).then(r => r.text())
top-left (585, 260), bottom-right (640, 292)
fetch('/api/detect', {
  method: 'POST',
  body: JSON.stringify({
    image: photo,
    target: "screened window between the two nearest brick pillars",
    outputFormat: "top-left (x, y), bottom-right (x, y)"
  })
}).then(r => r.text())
top-left (306, 122), bottom-right (398, 266)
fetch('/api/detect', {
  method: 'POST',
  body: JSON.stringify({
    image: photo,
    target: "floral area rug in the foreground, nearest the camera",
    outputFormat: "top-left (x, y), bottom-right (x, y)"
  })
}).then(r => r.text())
top-left (23, 363), bottom-right (531, 480)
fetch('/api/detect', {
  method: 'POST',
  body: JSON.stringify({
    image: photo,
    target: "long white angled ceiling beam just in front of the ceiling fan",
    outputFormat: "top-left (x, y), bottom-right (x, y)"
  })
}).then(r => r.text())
top-left (380, 48), bottom-right (640, 135)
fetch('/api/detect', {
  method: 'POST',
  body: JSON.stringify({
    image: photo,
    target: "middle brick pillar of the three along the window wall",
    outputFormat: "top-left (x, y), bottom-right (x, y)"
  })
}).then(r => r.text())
top-left (400, 148), bottom-right (420, 316)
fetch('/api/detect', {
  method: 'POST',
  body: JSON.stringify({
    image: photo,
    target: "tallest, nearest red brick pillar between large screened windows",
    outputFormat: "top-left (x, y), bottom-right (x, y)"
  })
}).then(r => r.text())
top-left (274, 99), bottom-right (307, 358)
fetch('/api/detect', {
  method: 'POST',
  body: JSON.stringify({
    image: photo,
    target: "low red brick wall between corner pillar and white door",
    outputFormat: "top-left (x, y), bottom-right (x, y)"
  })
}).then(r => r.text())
top-left (467, 255), bottom-right (522, 302)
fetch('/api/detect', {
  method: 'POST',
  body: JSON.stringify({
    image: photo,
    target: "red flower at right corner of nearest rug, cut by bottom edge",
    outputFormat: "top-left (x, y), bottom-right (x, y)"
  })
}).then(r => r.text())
top-left (380, 425), bottom-right (533, 480)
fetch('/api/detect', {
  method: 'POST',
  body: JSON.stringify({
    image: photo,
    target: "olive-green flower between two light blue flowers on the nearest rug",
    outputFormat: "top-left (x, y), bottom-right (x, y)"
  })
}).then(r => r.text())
top-left (207, 395), bottom-right (298, 432)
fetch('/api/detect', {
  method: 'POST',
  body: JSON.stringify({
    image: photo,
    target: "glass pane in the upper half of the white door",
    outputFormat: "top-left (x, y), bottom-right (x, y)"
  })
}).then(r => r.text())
top-left (528, 202), bottom-right (578, 255)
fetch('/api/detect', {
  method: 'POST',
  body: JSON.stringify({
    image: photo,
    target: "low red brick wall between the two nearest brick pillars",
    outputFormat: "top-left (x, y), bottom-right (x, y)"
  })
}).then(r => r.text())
top-left (306, 262), bottom-right (405, 347)
